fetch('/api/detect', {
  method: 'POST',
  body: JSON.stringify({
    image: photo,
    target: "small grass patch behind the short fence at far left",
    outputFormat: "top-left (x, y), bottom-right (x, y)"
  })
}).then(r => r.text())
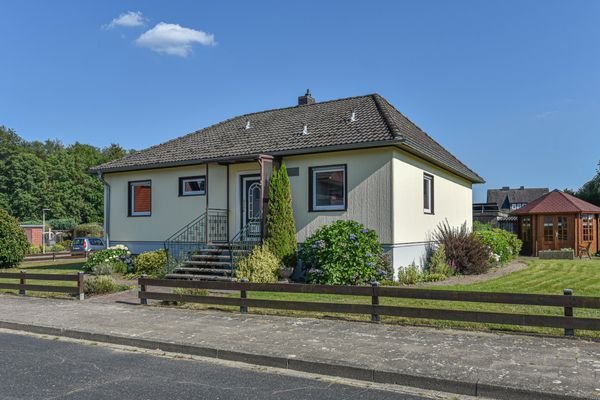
top-left (0, 258), bottom-right (85, 298)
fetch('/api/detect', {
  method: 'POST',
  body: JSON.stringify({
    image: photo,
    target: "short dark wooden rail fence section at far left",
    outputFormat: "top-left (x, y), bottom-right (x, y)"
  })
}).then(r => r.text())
top-left (0, 271), bottom-right (84, 300)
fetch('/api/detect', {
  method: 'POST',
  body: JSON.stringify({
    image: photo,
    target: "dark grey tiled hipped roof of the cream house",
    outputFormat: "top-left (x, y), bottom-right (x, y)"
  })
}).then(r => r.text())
top-left (92, 94), bottom-right (483, 183)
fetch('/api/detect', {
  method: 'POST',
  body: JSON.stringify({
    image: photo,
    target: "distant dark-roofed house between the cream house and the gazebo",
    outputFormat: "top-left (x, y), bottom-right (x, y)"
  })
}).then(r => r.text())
top-left (473, 186), bottom-right (548, 233)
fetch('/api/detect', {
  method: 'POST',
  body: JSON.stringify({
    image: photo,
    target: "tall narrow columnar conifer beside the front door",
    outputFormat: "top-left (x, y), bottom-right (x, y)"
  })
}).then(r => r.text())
top-left (265, 164), bottom-right (298, 268)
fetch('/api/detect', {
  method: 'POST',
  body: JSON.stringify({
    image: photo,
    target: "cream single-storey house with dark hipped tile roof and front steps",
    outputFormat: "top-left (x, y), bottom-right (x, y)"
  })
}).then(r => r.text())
top-left (93, 92), bottom-right (484, 267)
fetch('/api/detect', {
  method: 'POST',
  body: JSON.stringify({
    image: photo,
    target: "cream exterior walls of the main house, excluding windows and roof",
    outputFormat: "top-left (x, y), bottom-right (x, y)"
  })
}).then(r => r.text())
top-left (105, 147), bottom-right (472, 269)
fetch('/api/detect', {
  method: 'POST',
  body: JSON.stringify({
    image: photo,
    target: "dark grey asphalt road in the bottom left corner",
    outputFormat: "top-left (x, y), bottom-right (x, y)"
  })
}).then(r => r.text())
top-left (0, 332), bottom-right (440, 400)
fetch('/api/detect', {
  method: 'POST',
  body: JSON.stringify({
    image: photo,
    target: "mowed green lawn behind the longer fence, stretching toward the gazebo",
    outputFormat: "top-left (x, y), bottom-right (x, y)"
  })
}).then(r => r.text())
top-left (179, 259), bottom-right (600, 338)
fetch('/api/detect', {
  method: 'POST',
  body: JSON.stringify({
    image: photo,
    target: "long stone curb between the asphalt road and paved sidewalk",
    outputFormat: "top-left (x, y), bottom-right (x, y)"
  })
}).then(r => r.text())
top-left (0, 321), bottom-right (597, 400)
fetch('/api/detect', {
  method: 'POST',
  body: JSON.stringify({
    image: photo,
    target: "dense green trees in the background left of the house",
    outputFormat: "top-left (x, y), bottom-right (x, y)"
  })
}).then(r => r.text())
top-left (0, 125), bottom-right (129, 223)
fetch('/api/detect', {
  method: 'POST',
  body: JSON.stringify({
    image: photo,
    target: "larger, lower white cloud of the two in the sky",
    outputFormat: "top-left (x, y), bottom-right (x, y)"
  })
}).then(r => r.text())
top-left (135, 22), bottom-right (217, 57)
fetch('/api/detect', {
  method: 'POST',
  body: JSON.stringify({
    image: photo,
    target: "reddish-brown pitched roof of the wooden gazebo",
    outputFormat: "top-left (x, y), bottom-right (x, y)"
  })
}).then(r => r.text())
top-left (512, 190), bottom-right (600, 215)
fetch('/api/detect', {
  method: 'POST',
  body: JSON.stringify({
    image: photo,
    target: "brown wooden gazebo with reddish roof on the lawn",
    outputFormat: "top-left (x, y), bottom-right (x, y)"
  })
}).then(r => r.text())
top-left (512, 190), bottom-right (600, 256)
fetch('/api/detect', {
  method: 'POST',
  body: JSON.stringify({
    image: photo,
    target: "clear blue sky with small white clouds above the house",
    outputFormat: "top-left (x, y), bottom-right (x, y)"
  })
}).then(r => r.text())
top-left (0, 0), bottom-right (600, 201)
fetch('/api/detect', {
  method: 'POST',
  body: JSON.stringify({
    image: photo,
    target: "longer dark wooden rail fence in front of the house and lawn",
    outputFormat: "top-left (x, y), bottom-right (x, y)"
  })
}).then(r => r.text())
top-left (138, 277), bottom-right (600, 336)
